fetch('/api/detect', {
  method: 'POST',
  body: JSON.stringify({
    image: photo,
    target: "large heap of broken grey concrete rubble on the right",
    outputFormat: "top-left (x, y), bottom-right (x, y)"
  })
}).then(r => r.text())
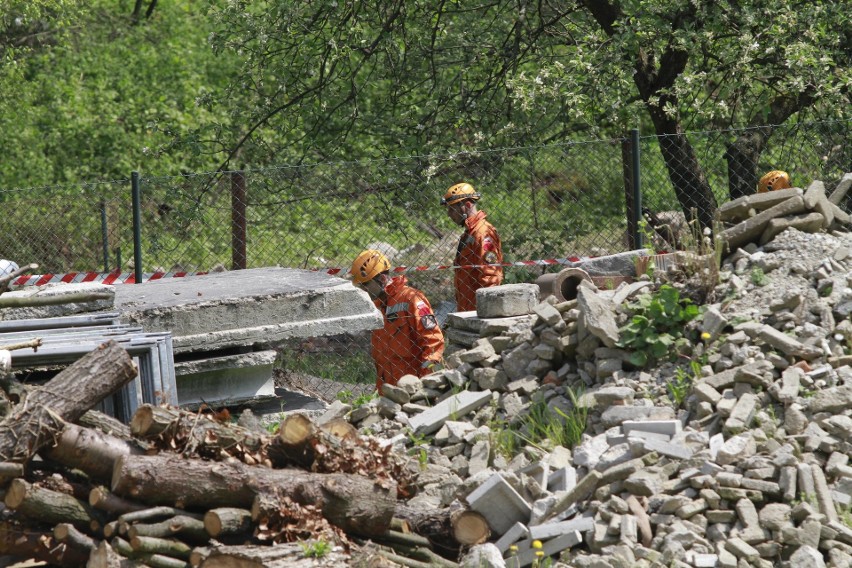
top-left (324, 174), bottom-right (852, 568)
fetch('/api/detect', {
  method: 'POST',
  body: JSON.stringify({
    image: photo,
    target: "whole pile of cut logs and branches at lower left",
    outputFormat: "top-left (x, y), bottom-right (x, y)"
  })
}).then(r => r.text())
top-left (0, 342), bottom-right (489, 568)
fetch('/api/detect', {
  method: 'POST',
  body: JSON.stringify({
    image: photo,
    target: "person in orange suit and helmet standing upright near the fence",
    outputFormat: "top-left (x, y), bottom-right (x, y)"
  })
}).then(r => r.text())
top-left (441, 183), bottom-right (503, 312)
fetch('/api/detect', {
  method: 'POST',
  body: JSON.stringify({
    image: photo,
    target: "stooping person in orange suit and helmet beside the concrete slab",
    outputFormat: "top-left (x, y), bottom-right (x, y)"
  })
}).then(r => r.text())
top-left (351, 249), bottom-right (444, 394)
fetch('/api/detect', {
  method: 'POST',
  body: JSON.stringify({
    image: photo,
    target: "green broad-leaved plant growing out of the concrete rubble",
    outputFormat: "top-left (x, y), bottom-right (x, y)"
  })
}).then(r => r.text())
top-left (618, 284), bottom-right (701, 367)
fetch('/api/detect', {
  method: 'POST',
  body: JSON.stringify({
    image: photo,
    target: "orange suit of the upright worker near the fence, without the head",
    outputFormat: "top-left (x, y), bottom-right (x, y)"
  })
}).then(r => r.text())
top-left (453, 211), bottom-right (503, 312)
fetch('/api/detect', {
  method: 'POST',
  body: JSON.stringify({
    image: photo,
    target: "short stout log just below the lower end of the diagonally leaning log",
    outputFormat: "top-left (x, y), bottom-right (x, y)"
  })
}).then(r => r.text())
top-left (39, 424), bottom-right (144, 483)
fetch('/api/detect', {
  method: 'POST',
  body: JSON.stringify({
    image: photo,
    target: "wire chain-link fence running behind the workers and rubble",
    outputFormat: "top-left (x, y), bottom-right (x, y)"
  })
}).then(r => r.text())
top-left (0, 121), bottom-right (852, 400)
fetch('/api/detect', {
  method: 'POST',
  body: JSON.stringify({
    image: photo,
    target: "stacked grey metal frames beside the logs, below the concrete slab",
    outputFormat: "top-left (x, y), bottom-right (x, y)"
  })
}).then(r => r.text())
top-left (0, 313), bottom-right (178, 422)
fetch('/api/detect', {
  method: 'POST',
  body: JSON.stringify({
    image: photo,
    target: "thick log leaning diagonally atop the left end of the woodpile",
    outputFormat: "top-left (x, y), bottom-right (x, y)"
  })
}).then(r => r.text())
top-left (0, 341), bottom-right (136, 462)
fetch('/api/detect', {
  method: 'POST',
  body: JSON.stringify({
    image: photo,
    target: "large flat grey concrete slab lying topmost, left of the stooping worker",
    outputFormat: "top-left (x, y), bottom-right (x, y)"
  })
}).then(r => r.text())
top-left (114, 268), bottom-right (383, 354)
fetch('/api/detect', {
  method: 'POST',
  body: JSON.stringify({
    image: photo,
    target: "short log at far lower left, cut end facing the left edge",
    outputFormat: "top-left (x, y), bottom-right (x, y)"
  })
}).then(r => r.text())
top-left (5, 479), bottom-right (103, 530)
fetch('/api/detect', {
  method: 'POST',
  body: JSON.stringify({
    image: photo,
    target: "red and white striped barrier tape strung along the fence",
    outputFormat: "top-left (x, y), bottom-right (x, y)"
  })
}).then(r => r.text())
top-left (11, 256), bottom-right (580, 287)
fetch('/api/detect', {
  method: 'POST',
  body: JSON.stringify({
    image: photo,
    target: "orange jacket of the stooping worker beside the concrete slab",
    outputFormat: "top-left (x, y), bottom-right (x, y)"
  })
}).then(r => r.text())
top-left (370, 276), bottom-right (444, 394)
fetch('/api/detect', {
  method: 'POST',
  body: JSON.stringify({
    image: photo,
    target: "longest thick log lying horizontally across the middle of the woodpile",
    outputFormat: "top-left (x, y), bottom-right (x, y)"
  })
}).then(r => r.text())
top-left (112, 455), bottom-right (396, 536)
